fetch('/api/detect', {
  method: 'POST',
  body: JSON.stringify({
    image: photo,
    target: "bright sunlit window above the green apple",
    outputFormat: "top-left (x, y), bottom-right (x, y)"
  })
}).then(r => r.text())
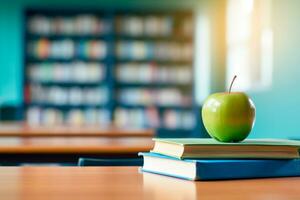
top-left (226, 0), bottom-right (273, 91)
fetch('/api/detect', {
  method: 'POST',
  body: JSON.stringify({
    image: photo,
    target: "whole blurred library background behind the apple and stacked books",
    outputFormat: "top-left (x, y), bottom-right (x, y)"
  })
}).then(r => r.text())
top-left (0, 0), bottom-right (300, 162)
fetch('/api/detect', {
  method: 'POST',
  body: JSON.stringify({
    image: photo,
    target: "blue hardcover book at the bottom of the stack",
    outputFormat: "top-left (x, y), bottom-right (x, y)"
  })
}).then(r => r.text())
top-left (139, 153), bottom-right (300, 180)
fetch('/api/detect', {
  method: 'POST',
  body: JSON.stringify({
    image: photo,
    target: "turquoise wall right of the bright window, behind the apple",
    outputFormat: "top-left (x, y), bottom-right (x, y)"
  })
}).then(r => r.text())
top-left (251, 0), bottom-right (300, 138)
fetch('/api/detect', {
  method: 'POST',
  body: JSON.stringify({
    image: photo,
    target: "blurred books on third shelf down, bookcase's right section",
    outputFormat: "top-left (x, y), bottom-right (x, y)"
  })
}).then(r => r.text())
top-left (116, 63), bottom-right (193, 84)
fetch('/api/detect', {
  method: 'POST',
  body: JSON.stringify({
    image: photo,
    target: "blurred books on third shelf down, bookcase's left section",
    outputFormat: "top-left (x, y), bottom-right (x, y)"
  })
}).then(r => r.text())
top-left (28, 62), bottom-right (106, 83)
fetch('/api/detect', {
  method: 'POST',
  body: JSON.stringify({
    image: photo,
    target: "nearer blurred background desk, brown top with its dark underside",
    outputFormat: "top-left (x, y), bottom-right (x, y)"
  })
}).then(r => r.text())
top-left (0, 136), bottom-right (153, 166)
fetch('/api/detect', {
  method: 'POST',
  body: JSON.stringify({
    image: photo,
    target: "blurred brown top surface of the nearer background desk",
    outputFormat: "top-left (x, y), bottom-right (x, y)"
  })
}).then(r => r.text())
top-left (0, 136), bottom-right (154, 154)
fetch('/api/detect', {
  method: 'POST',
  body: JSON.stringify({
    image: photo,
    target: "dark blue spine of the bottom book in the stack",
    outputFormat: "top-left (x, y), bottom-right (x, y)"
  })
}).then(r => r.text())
top-left (196, 160), bottom-right (300, 180)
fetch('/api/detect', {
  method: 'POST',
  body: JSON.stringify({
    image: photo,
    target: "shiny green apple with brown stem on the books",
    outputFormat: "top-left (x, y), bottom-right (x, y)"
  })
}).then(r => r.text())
top-left (202, 76), bottom-right (255, 142)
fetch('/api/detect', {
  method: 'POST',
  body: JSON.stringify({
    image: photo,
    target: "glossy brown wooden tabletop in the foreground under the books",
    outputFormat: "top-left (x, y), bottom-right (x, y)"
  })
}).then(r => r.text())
top-left (0, 167), bottom-right (300, 200)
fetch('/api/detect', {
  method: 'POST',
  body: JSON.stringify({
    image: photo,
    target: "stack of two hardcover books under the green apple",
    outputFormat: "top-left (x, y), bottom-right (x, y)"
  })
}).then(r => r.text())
top-left (140, 138), bottom-right (300, 180)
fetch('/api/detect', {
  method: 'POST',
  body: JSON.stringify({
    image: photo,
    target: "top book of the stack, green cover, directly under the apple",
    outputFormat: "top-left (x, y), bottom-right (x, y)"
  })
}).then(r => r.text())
top-left (151, 138), bottom-right (300, 159)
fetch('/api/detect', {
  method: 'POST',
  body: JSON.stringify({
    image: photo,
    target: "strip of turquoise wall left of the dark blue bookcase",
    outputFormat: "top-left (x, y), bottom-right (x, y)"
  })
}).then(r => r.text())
top-left (0, 2), bottom-right (23, 104)
